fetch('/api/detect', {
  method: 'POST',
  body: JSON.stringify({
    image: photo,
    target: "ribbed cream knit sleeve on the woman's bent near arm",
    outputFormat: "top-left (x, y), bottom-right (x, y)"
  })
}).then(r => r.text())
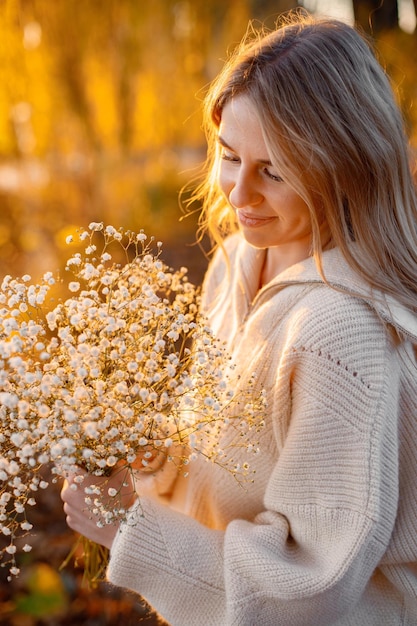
top-left (108, 294), bottom-right (398, 626)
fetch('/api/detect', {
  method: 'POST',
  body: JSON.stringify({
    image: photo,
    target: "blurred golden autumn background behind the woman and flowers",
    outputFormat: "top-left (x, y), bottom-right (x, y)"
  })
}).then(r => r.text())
top-left (0, 0), bottom-right (417, 626)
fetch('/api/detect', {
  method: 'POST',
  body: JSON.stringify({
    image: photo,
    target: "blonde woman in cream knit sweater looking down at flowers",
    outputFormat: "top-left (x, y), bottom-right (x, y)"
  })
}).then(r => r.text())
top-left (62, 16), bottom-right (417, 626)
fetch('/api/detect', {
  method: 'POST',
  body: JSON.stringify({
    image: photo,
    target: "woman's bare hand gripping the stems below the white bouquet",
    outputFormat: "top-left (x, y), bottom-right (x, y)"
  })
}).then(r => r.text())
top-left (61, 467), bottom-right (136, 549)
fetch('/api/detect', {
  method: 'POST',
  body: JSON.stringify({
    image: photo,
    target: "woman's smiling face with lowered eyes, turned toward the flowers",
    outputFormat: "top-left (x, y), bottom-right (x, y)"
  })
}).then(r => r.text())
top-left (218, 96), bottom-right (312, 263)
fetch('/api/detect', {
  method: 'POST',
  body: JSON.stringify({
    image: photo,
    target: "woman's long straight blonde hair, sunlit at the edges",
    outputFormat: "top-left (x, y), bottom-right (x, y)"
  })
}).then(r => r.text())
top-left (191, 14), bottom-right (417, 310)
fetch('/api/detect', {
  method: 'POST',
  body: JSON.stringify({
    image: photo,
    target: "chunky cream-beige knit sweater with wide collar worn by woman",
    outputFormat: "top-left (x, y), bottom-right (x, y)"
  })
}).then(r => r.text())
top-left (108, 236), bottom-right (417, 626)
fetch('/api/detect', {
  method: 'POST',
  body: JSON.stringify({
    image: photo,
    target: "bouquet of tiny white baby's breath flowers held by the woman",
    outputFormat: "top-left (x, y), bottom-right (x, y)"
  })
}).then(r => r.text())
top-left (0, 223), bottom-right (264, 575)
